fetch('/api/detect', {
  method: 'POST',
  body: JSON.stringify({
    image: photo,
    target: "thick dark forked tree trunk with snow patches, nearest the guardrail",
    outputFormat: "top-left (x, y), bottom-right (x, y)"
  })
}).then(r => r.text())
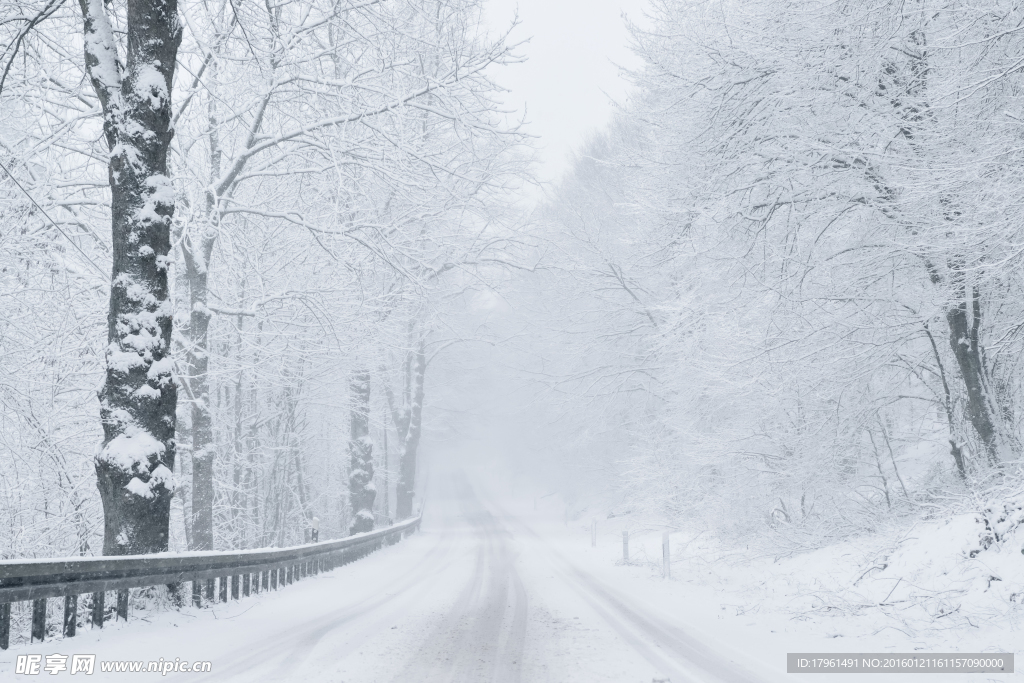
top-left (79, 0), bottom-right (181, 555)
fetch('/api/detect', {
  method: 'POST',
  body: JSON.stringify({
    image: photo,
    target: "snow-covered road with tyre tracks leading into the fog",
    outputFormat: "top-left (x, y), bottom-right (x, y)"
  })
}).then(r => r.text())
top-left (3, 462), bottom-right (777, 683)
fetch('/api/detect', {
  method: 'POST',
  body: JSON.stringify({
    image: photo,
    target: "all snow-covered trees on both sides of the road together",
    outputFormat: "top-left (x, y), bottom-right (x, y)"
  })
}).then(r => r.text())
top-left (0, 0), bottom-right (1024, 557)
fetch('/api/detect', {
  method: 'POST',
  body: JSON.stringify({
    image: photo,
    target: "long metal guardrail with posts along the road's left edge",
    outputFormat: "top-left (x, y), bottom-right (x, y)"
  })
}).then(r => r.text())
top-left (0, 516), bottom-right (422, 650)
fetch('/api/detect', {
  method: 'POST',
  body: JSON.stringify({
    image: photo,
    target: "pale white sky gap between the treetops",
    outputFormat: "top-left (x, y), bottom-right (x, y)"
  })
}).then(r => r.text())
top-left (486, 0), bottom-right (645, 181)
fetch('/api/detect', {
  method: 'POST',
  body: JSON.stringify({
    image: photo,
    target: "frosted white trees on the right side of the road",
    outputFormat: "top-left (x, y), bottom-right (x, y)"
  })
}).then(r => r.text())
top-left (524, 0), bottom-right (1024, 548)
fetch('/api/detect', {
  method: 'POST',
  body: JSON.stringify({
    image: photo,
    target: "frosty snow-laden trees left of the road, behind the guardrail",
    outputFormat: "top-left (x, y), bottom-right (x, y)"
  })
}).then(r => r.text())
top-left (0, 0), bottom-right (523, 557)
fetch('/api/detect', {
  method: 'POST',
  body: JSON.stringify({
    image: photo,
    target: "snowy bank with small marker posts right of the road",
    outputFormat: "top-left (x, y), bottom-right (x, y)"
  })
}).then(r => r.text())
top-left (473, 466), bottom-right (1024, 683)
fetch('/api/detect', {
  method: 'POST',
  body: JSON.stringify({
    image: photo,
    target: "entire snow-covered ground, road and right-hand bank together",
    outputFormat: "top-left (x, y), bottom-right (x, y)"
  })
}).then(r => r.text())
top-left (0, 450), bottom-right (1022, 683)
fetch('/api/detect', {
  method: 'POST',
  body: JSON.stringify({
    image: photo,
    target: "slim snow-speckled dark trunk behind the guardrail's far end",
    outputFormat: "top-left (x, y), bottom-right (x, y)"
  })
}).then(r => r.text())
top-left (348, 372), bottom-right (377, 533)
